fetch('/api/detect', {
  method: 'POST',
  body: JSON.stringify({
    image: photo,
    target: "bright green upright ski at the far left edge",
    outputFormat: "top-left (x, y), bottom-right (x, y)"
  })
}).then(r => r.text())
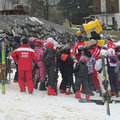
top-left (1, 42), bottom-right (5, 94)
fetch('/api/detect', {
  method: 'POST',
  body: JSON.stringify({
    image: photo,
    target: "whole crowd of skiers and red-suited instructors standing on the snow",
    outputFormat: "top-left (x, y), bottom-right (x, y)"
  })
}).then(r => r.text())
top-left (0, 33), bottom-right (120, 99)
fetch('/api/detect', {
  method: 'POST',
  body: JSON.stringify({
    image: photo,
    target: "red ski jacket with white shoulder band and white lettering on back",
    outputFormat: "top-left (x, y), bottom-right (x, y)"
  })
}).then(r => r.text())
top-left (11, 45), bottom-right (38, 70)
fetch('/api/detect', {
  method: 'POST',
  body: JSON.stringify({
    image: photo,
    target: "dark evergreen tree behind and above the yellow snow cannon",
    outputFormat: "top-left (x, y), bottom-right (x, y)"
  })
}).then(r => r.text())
top-left (58, 0), bottom-right (93, 27)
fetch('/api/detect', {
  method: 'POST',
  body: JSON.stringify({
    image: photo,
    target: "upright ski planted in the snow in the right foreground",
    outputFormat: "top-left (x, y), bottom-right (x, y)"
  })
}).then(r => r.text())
top-left (101, 56), bottom-right (111, 115)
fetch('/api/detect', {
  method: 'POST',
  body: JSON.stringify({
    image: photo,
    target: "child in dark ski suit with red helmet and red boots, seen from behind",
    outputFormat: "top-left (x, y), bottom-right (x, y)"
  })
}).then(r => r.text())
top-left (43, 42), bottom-right (57, 95)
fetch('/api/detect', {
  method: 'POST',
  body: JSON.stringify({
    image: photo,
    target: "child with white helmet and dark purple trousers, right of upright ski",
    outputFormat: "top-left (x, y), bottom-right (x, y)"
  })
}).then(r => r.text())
top-left (107, 48), bottom-right (119, 97)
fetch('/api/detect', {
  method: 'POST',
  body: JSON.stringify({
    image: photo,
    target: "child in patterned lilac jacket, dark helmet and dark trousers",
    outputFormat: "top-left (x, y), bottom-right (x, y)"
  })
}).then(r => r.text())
top-left (81, 46), bottom-right (96, 96)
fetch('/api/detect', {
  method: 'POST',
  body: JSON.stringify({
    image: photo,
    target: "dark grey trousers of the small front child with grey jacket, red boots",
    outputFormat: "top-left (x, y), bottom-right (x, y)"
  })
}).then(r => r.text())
top-left (74, 77), bottom-right (90, 94)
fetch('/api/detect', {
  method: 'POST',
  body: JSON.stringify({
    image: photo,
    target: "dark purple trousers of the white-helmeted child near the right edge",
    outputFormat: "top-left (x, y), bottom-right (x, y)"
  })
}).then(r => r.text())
top-left (109, 67), bottom-right (119, 93)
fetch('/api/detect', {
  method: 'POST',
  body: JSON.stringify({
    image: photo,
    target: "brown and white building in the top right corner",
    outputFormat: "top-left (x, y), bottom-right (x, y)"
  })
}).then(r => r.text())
top-left (84, 0), bottom-right (120, 30)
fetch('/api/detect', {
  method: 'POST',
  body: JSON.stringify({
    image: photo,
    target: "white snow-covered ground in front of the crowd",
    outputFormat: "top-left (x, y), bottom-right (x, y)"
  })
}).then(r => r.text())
top-left (0, 69), bottom-right (120, 120)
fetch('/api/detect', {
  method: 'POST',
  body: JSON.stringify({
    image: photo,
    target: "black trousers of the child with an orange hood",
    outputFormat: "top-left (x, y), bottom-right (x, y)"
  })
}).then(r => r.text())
top-left (60, 74), bottom-right (74, 90)
